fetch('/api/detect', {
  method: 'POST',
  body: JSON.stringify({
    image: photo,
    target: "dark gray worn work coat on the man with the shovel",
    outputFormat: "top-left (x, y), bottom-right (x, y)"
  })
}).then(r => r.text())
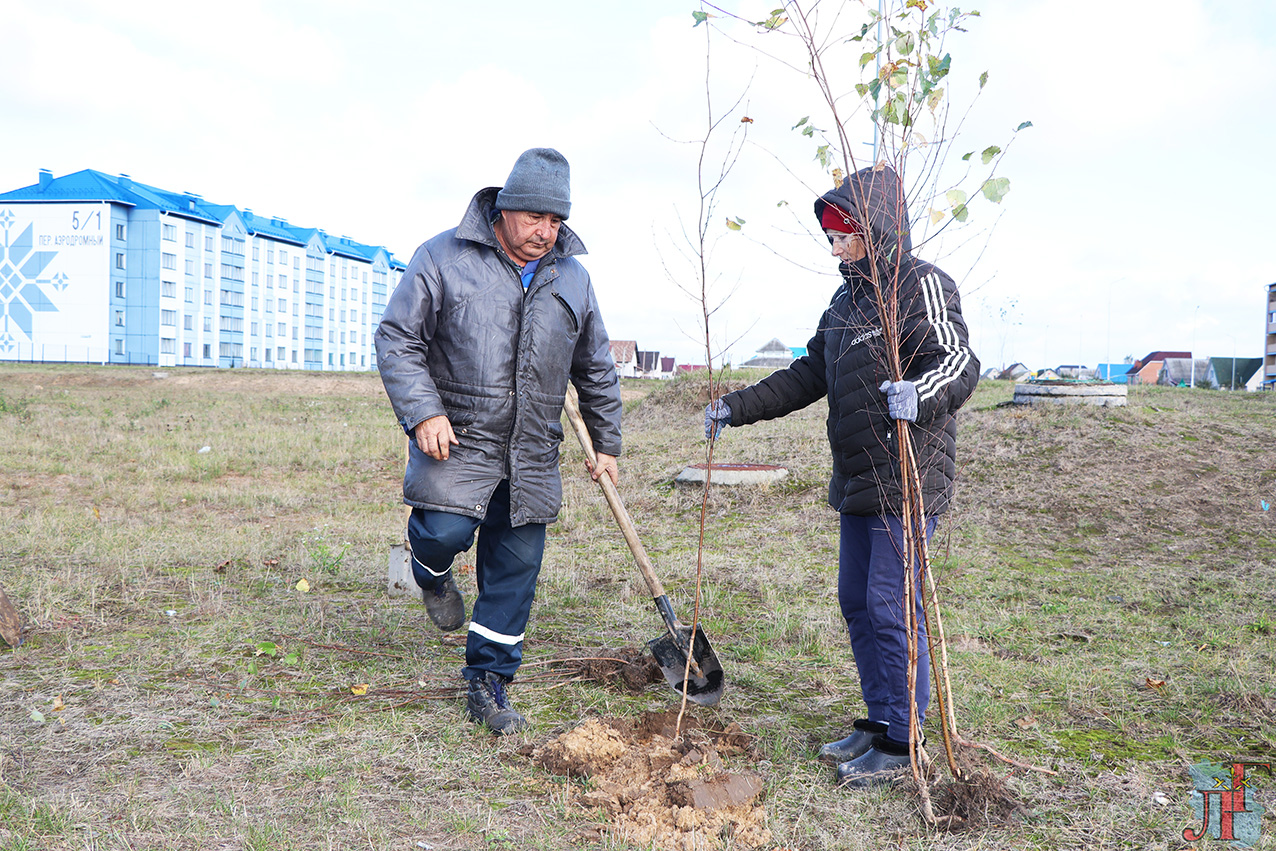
top-left (374, 188), bottom-right (620, 526)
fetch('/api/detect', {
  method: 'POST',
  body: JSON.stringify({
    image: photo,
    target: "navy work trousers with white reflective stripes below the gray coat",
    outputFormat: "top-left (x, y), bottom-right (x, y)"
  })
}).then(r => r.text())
top-left (408, 480), bottom-right (545, 680)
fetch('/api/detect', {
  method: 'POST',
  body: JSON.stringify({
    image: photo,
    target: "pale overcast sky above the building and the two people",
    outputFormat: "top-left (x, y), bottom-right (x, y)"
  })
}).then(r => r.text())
top-left (0, 0), bottom-right (1276, 369)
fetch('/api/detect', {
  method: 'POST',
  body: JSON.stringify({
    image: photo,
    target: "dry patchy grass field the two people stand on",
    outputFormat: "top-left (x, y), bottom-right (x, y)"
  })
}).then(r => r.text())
top-left (0, 364), bottom-right (1276, 851)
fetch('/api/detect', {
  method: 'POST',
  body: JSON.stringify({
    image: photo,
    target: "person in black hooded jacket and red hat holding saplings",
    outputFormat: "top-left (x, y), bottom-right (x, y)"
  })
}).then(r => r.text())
top-left (706, 168), bottom-right (979, 787)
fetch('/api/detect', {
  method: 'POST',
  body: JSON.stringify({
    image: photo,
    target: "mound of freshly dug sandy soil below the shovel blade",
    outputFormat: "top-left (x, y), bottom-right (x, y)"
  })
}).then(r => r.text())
top-left (531, 708), bottom-right (771, 851)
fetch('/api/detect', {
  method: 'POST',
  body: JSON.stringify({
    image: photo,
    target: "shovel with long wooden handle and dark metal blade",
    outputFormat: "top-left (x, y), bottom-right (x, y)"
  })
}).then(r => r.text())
top-left (563, 387), bottom-right (722, 706)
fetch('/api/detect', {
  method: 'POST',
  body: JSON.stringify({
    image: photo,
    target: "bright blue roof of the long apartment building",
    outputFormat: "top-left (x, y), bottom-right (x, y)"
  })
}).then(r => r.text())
top-left (0, 168), bottom-right (407, 269)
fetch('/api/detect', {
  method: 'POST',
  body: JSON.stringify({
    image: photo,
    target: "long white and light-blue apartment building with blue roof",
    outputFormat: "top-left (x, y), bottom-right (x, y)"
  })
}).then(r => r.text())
top-left (0, 170), bottom-right (404, 370)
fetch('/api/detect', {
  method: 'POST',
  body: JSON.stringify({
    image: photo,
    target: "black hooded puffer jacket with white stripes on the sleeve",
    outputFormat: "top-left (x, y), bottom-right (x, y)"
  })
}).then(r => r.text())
top-left (723, 168), bottom-right (979, 515)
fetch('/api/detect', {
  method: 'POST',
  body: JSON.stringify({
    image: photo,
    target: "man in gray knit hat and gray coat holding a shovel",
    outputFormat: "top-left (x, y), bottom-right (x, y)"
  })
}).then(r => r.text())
top-left (375, 148), bottom-right (620, 734)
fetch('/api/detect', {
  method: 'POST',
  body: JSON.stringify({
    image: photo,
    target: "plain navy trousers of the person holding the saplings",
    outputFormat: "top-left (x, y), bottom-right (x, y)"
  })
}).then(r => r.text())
top-left (837, 514), bottom-right (935, 741)
